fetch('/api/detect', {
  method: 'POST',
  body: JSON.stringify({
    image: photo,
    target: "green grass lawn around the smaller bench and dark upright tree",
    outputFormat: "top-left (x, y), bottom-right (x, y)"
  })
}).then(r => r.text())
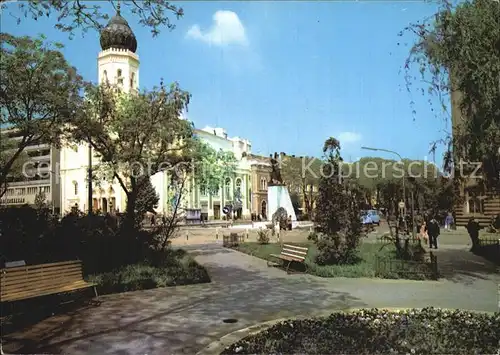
top-left (235, 243), bottom-right (423, 279)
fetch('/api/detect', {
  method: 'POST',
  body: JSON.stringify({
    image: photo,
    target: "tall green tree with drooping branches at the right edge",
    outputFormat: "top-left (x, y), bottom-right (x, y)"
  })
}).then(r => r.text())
top-left (401, 0), bottom-right (500, 186)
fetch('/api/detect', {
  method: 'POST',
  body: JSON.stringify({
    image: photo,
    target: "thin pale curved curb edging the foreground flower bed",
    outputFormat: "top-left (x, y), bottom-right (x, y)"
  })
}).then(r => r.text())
top-left (196, 307), bottom-right (496, 355)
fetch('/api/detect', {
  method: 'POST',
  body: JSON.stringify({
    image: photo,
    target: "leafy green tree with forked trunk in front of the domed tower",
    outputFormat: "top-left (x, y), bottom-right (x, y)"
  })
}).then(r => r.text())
top-left (72, 82), bottom-right (195, 231)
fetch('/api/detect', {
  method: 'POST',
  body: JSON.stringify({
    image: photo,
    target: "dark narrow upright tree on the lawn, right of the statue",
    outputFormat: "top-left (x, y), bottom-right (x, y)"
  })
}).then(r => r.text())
top-left (315, 137), bottom-right (362, 264)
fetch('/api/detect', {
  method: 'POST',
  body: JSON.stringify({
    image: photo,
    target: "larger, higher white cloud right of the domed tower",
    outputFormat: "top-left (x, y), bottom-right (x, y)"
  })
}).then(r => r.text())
top-left (186, 10), bottom-right (248, 46)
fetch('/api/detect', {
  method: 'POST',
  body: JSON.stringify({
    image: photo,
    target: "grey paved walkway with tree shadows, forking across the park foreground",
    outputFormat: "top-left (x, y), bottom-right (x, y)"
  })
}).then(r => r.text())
top-left (4, 244), bottom-right (500, 355)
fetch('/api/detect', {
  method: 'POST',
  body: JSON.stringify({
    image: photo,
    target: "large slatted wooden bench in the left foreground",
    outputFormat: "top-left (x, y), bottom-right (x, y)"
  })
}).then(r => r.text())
top-left (0, 260), bottom-right (99, 303)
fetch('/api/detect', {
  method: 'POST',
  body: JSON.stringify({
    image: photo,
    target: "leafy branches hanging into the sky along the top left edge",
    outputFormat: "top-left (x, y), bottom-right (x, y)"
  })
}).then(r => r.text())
top-left (0, 0), bottom-right (184, 36)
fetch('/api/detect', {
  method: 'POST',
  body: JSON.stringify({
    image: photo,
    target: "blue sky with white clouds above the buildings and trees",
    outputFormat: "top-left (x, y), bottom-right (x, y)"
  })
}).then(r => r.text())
top-left (1, 1), bottom-right (449, 166)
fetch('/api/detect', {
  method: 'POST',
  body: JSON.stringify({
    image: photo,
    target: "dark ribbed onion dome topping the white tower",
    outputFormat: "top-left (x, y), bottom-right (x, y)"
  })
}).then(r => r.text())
top-left (100, 10), bottom-right (137, 53)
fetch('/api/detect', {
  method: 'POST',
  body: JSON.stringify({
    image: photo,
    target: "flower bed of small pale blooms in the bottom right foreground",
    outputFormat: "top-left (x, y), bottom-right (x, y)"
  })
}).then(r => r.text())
top-left (222, 308), bottom-right (500, 355)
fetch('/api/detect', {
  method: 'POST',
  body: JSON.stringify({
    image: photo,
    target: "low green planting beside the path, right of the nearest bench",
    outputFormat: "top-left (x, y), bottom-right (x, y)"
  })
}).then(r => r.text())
top-left (86, 249), bottom-right (210, 294)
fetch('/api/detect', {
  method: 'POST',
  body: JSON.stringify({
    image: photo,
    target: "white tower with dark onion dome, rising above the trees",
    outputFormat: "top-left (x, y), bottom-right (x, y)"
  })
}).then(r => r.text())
top-left (97, 3), bottom-right (139, 92)
